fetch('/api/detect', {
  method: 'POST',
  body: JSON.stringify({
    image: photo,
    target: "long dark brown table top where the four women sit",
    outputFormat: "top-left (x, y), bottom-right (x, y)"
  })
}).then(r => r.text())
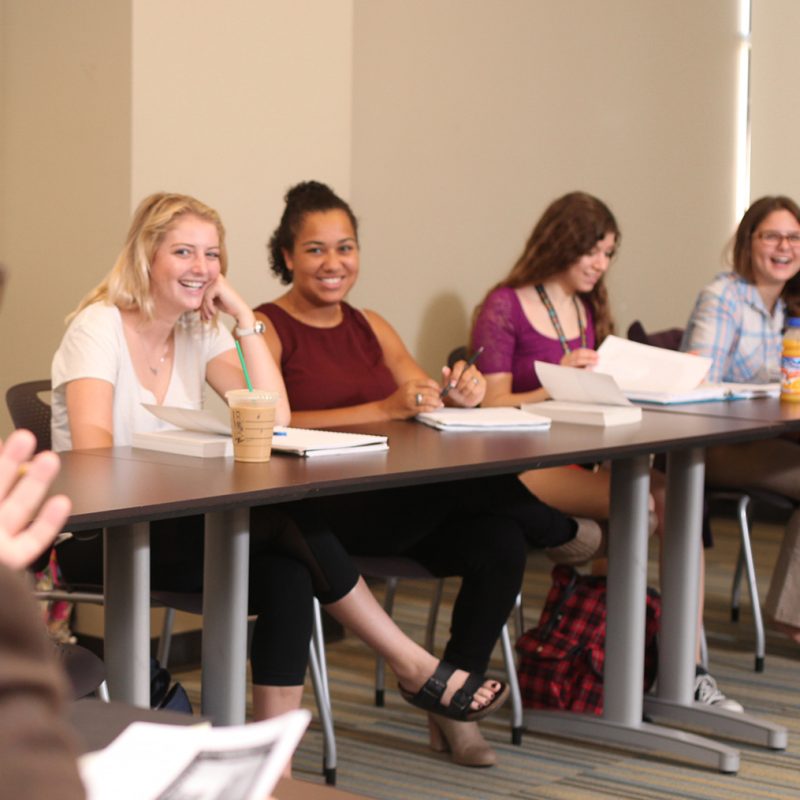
top-left (53, 411), bottom-right (778, 530)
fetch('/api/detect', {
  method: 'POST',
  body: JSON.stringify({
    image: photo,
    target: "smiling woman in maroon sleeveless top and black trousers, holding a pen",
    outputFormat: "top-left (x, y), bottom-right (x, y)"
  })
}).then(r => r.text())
top-left (256, 182), bottom-right (592, 766)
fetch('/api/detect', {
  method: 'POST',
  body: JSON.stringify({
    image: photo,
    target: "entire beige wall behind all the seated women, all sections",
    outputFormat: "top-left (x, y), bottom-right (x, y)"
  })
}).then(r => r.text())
top-left (0, 0), bottom-right (788, 434)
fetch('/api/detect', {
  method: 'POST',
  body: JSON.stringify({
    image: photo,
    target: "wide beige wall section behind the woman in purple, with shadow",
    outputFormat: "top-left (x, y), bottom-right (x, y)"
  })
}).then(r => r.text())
top-left (353, 0), bottom-right (736, 370)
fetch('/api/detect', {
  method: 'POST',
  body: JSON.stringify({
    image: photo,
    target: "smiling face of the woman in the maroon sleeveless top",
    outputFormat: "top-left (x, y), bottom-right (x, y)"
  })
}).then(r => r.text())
top-left (283, 209), bottom-right (359, 307)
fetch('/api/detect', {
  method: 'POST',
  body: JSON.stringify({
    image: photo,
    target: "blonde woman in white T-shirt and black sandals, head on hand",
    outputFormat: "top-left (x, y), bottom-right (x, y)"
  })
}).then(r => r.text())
top-left (53, 193), bottom-right (506, 764)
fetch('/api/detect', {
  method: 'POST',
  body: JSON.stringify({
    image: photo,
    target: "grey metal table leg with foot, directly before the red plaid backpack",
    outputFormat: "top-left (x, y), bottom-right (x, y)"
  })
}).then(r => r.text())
top-left (525, 456), bottom-right (739, 772)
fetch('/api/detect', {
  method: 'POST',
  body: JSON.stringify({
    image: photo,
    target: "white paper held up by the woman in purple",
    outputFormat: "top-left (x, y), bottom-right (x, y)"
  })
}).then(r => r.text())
top-left (594, 336), bottom-right (711, 393)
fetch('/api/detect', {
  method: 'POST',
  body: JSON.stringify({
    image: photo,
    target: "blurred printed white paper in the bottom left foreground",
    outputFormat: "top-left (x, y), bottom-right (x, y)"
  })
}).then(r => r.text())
top-left (78, 710), bottom-right (311, 800)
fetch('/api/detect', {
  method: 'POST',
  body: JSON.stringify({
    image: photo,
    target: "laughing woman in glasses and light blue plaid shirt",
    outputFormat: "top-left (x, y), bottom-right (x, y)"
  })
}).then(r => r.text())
top-left (681, 196), bottom-right (800, 644)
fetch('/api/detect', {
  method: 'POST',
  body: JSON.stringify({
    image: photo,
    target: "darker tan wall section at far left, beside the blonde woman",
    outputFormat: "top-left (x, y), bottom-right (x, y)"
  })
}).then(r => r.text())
top-left (0, 0), bottom-right (131, 434)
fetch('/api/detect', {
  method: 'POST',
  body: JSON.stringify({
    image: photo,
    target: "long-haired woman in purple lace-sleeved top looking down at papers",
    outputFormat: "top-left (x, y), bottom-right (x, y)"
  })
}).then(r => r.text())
top-left (472, 192), bottom-right (742, 711)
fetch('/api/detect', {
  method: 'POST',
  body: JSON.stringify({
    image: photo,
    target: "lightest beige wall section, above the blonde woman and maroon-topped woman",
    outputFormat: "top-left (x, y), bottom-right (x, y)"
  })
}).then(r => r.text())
top-left (131, 0), bottom-right (353, 316)
